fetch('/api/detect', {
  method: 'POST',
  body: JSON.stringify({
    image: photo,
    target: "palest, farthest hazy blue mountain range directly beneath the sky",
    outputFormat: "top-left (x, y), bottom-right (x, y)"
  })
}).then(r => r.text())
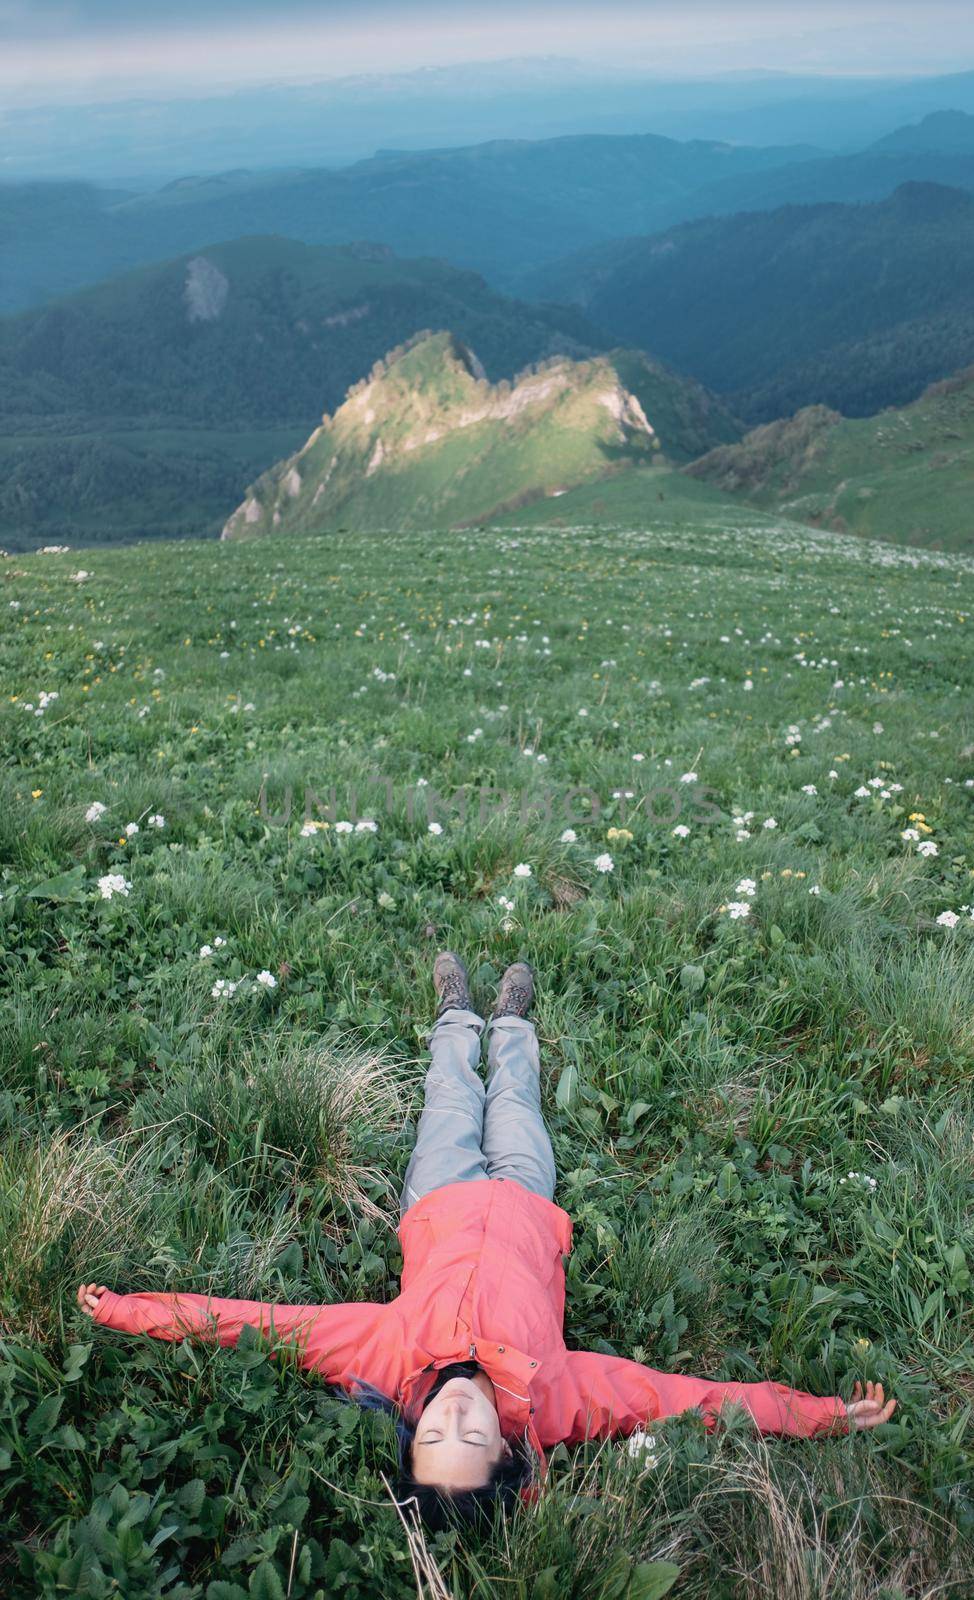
top-left (11, 54), bottom-right (974, 187)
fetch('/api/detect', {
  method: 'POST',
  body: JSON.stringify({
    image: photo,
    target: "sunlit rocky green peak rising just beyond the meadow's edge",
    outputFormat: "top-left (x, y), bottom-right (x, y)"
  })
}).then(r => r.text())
top-left (222, 333), bottom-right (739, 539)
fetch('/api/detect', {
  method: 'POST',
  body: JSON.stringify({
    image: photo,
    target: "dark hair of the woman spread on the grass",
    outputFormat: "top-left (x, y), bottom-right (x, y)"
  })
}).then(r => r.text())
top-left (342, 1379), bottom-right (534, 1533)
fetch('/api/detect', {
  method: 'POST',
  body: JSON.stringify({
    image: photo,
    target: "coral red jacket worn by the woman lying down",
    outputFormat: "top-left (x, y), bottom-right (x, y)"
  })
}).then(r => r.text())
top-left (94, 1178), bottom-right (848, 1470)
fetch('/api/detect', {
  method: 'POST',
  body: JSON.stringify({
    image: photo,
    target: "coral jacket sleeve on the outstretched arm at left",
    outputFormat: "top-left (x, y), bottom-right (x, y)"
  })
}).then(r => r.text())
top-left (94, 1290), bottom-right (387, 1384)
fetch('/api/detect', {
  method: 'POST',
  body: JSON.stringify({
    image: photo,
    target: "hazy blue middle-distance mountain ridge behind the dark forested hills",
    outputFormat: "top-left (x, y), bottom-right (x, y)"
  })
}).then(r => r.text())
top-left (7, 112), bottom-right (974, 312)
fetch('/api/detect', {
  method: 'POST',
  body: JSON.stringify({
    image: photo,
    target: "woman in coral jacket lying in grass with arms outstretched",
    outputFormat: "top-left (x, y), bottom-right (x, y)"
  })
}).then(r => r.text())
top-left (78, 952), bottom-right (896, 1525)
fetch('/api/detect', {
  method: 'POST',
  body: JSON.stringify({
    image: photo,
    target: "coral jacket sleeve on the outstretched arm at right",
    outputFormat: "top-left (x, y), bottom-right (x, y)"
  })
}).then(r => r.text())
top-left (563, 1350), bottom-right (849, 1443)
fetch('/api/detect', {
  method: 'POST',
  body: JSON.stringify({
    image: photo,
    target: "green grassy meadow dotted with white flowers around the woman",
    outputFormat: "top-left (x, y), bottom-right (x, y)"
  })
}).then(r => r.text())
top-left (0, 515), bottom-right (974, 1600)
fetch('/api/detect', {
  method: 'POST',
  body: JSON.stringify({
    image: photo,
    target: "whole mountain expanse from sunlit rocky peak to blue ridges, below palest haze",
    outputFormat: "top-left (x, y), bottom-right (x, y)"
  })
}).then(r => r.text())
top-left (0, 100), bottom-right (974, 560)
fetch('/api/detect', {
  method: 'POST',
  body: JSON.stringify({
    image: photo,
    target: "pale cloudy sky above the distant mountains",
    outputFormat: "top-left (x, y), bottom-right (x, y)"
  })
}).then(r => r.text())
top-left (0, 0), bottom-right (974, 106)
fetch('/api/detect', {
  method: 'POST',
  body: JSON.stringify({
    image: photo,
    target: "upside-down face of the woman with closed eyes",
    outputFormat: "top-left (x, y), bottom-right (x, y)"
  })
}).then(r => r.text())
top-left (406, 1373), bottom-right (510, 1494)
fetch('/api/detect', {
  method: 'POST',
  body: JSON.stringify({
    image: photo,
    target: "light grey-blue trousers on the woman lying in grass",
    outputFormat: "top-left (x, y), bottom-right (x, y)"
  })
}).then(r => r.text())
top-left (400, 1006), bottom-right (555, 1213)
